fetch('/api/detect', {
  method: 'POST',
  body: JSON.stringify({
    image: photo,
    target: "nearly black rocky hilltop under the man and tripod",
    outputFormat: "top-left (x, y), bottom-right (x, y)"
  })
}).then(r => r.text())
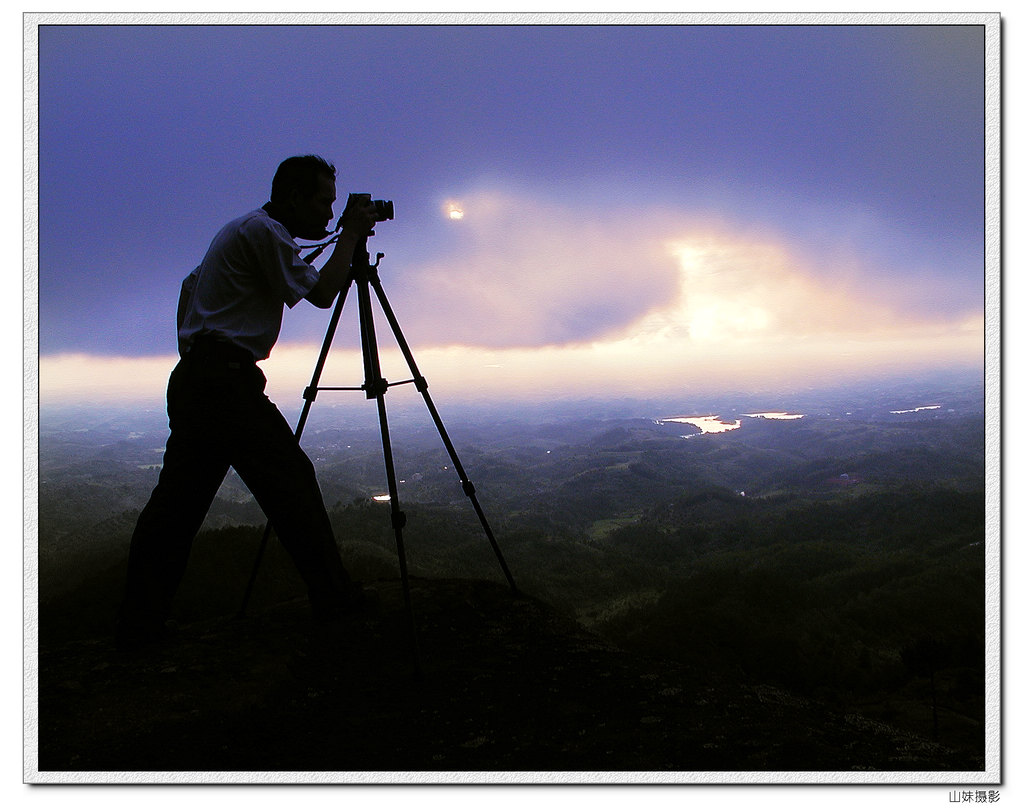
top-left (32, 580), bottom-right (984, 781)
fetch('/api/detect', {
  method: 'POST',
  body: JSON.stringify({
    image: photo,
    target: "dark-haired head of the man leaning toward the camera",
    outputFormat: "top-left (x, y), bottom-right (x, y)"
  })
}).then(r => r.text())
top-left (270, 155), bottom-right (337, 240)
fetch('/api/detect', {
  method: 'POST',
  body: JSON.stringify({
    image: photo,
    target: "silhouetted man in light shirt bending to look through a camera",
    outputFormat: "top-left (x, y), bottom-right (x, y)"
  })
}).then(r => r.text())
top-left (117, 156), bottom-right (375, 648)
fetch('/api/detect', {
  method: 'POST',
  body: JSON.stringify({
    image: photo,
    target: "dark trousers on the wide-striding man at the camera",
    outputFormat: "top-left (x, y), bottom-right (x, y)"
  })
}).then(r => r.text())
top-left (120, 343), bottom-right (352, 628)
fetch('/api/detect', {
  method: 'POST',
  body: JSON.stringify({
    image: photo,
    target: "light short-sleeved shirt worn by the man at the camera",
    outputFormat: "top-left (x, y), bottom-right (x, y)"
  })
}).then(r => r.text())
top-left (178, 208), bottom-right (319, 361)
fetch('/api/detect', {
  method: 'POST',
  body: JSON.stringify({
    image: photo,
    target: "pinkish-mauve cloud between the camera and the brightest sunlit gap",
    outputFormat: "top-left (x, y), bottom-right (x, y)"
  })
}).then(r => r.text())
top-left (395, 193), bottom-right (679, 347)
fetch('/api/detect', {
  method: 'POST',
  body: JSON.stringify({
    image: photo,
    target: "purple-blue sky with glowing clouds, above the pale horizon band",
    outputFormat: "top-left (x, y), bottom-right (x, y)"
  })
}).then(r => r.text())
top-left (39, 20), bottom-right (985, 405)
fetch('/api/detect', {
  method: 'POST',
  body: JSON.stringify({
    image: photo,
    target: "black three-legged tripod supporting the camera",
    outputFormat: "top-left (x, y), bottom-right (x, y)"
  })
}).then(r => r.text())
top-left (239, 231), bottom-right (518, 675)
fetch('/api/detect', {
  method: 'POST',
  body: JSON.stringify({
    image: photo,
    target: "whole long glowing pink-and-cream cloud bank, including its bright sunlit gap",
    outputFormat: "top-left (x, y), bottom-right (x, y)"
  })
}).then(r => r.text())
top-left (389, 193), bottom-right (980, 348)
